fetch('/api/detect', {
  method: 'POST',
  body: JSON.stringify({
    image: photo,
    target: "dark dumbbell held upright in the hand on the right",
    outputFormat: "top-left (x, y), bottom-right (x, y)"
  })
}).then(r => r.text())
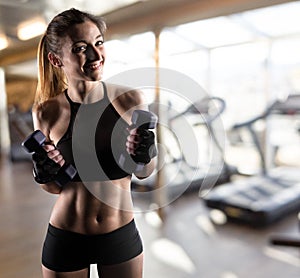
top-left (119, 110), bottom-right (157, 173)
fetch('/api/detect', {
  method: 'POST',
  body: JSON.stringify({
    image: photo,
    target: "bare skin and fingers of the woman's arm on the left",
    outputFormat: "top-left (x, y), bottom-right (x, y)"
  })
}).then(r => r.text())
top-left (32, 107), bottom-right (65, 194)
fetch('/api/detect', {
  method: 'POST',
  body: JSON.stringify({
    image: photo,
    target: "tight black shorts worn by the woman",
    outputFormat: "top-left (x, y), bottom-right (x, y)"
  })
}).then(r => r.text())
top-left (42, 220), bottom-right (143, 272)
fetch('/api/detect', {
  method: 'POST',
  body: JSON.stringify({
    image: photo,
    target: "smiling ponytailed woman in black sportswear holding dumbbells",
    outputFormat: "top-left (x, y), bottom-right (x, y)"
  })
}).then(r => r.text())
top-left (33, 9), bottom-right (155, 278)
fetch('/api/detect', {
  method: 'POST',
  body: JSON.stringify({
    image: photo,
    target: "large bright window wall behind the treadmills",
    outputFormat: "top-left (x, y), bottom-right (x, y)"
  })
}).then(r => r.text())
top-left (103, 1), bottom-right (300, 169)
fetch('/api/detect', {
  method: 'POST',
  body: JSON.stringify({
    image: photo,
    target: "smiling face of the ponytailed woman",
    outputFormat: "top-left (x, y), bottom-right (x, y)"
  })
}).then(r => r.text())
top-left (60, 21), bottom-right (105, 81)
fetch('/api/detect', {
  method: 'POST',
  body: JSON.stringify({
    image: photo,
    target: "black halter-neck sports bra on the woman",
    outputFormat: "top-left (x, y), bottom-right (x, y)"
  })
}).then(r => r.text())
top-left (56, 82), bottom-right (130, 181)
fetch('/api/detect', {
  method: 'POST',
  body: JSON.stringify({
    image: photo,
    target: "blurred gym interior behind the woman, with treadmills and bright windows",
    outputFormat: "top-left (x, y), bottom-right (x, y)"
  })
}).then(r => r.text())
top-left (0, 0), bottom-right (300, 278)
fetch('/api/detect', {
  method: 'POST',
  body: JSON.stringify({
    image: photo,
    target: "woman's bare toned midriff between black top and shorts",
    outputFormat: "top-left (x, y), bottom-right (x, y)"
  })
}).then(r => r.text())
top-left (50, 179), bottom-right (133, 234)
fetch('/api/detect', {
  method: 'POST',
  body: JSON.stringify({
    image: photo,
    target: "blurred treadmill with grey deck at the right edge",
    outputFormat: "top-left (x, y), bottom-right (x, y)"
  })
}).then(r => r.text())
top-left (201, 95), bottom-right (300, 227)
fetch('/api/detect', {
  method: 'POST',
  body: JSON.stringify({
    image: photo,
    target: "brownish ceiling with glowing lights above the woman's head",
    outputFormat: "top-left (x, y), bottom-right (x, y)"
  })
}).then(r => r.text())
top-left (0, 0), bottom-right (296, 78)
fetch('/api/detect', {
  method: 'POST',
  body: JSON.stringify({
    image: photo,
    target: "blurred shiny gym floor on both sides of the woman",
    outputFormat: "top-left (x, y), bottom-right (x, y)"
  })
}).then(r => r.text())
top-left (0, 159), bottom-right (300, 278)
